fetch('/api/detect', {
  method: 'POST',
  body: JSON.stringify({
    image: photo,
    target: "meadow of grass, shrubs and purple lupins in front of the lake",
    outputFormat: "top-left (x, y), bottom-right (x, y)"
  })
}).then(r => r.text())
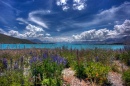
top-left (0, 47), bottom-right (129, 86)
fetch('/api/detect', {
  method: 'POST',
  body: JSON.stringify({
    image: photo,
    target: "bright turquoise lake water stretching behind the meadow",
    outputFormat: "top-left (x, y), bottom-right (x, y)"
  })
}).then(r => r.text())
top-left (0, 43), bottom-right (124, 50)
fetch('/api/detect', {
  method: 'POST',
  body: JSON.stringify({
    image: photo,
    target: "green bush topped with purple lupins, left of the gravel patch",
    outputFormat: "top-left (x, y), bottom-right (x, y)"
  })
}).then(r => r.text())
top-left (30, 55), bottom-right (66, 86)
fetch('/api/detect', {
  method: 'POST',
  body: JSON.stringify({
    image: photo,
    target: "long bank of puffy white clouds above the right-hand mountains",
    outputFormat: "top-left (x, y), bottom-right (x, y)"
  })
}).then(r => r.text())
top-left (72, 20), bottom-right (130, 41)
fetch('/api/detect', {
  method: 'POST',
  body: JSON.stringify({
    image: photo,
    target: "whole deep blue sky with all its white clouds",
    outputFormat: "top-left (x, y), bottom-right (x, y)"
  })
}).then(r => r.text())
top-left (0, 0), bottom-right (130, 42)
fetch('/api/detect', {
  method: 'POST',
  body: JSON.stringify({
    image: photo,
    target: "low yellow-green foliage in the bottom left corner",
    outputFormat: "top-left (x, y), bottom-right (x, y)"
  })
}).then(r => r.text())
top-left (0, 71), bottom-right (30, 86)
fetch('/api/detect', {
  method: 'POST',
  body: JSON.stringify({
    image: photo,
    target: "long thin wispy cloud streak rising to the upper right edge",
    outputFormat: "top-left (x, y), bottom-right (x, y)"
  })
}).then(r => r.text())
top-left (73, 2), bottom-right (130, 27)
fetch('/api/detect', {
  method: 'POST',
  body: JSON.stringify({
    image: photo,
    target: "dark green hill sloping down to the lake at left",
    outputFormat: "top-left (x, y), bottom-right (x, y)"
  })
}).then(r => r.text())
top-left (0, 33), bottom-right (34, 44)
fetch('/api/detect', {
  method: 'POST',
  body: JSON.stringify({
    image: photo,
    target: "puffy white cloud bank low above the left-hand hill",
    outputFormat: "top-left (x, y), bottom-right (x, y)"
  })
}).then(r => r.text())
top-left (0, 24), bottom-right (51, 39)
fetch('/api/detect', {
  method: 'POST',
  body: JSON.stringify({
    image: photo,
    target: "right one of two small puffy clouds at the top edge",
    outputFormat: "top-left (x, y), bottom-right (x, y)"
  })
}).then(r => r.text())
top-left (73, 0), bottom-right (87, 10)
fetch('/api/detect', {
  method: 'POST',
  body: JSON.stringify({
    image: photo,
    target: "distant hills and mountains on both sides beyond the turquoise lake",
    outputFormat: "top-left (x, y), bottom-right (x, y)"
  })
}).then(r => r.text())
top-left (0, 33), bottom-right (130, 44)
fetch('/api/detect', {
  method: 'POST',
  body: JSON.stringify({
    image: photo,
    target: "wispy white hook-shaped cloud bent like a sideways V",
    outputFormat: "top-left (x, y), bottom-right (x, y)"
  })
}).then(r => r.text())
top-left (28, 10), bottom-right (51, 29)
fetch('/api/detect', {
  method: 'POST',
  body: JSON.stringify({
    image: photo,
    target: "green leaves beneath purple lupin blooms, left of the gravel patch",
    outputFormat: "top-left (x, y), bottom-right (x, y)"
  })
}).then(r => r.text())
top-left (31, 58), bottom-right (64, 86)
